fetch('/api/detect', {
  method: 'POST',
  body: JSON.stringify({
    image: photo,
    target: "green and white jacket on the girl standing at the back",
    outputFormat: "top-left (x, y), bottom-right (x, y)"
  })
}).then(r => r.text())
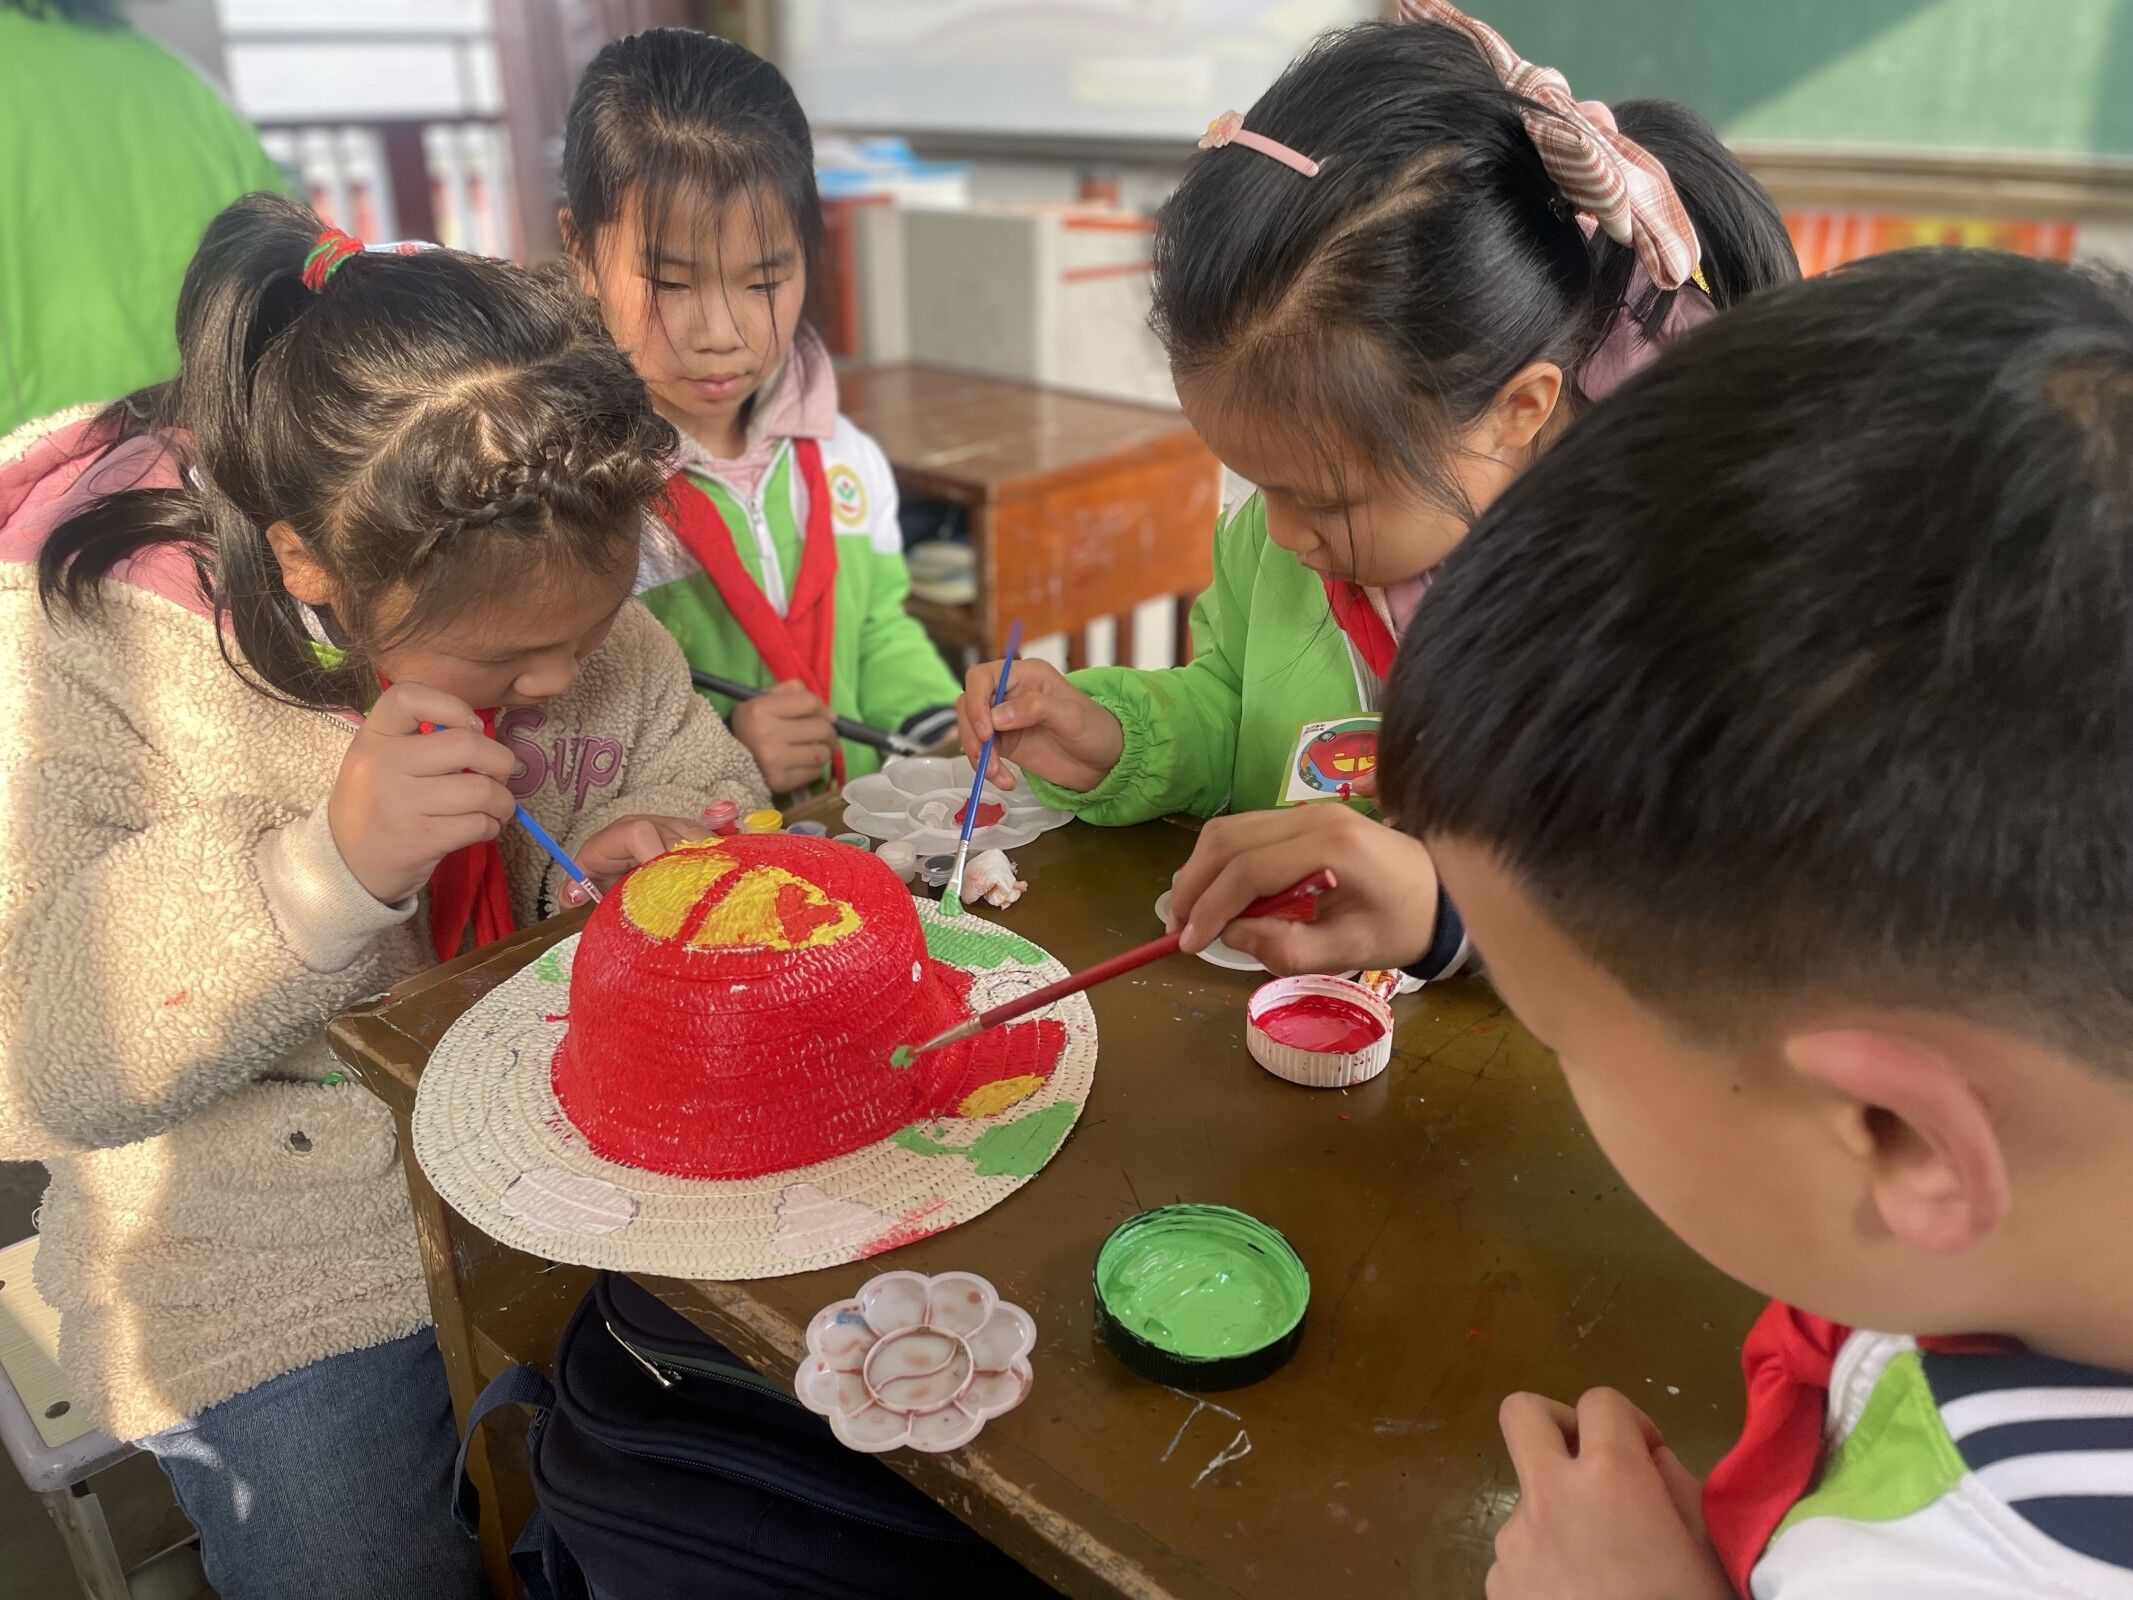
top-left (638, 416), bottom-right (960, 779)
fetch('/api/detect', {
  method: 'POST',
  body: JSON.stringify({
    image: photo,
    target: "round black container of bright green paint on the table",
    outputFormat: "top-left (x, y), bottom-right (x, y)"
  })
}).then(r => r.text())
top-left (1094, 1205), bottom-right (1312, 1389)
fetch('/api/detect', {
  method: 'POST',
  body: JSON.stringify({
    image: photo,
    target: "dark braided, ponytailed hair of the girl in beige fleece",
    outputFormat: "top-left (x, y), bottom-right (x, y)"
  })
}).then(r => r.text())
top-left (38, 194), bottom-right (678, 706)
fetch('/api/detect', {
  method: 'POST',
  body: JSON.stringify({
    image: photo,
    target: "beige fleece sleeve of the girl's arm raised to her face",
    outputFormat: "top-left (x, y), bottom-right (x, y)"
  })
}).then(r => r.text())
top-left (0, 591), bottom-right (412, 1161)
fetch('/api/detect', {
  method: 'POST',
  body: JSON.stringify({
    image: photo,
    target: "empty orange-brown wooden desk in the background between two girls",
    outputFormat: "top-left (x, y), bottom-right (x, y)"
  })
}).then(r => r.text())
top-left (838, 365), bottom-right (1222, 666)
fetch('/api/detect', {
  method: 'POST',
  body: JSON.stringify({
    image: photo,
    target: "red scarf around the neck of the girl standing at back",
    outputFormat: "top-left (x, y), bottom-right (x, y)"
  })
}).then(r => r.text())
top-left (661, 439), bottom-right (845, 783)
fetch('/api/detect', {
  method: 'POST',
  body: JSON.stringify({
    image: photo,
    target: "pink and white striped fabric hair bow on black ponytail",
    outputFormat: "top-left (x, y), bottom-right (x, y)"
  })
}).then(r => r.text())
top-left (1399, 0), bottom-right (1702, 290)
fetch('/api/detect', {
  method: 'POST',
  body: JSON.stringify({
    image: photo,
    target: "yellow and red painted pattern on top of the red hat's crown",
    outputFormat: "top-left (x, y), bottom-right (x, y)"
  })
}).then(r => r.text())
top-left (623, 838), bottom-right (860, 951)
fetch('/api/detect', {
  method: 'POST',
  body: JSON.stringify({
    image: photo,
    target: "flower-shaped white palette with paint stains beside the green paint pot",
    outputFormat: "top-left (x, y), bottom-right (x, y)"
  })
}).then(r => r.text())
top-left (793, 1271), bottom-right (1037, 1453)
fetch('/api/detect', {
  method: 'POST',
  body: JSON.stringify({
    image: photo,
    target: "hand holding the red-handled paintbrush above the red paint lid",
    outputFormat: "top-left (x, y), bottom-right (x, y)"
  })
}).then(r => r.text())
top-left (1171, 802), bottom-right (1438, 973)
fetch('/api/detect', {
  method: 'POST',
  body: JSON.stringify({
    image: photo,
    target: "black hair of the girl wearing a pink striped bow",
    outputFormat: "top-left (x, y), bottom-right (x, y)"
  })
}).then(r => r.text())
top-left (1152, 20), bottom-right (1798, 501)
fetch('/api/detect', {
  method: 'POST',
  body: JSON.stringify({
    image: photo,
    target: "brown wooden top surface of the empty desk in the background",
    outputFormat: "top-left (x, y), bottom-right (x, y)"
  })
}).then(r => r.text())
top-left (836, 365), bottom-right (1201, 493)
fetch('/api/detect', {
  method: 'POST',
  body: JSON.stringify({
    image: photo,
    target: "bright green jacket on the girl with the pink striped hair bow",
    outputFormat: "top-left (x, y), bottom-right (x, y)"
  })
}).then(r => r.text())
top-left (1030, 495), bottom-right (1378, 826)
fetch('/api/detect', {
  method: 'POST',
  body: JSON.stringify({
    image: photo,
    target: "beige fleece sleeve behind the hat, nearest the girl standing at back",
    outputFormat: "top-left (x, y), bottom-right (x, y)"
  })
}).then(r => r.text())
top-left (544, 599), bottom-right (770, 894)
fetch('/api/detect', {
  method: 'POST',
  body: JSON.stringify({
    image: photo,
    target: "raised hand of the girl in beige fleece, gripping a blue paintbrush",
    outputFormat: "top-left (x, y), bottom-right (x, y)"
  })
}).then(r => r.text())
top-left (326, 683), bottom-right (518, 905)
